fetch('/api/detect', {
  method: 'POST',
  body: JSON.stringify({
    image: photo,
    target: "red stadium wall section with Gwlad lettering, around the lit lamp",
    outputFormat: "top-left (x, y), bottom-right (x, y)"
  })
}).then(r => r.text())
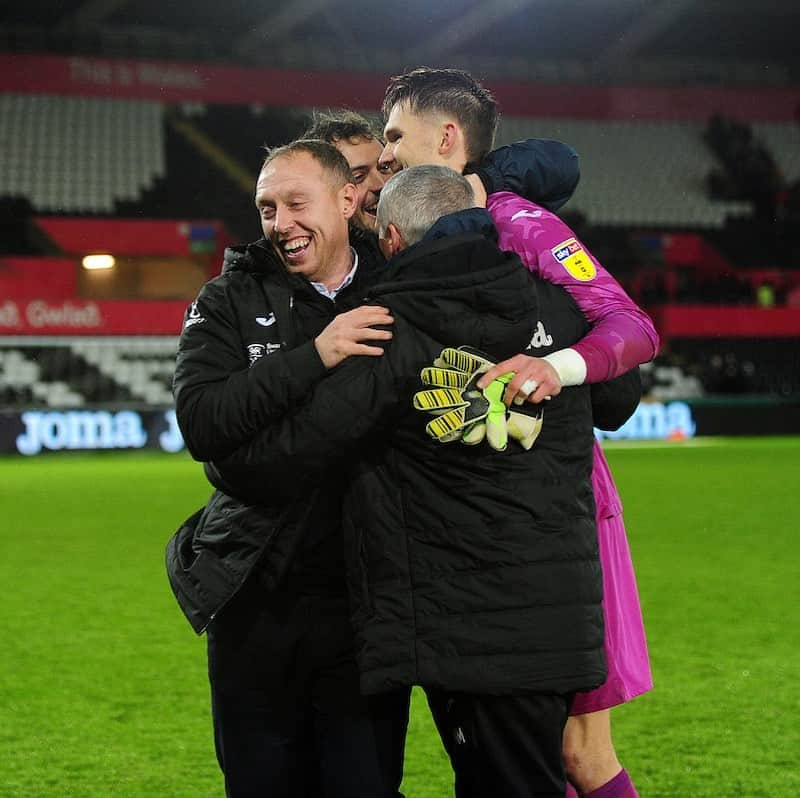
top-left (0, 216), bottom-right (231, 336)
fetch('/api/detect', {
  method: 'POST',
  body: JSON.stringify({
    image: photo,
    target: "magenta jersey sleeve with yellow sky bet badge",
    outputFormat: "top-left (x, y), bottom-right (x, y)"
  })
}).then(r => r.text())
top-left (486, 191), bottom-right (658, 382)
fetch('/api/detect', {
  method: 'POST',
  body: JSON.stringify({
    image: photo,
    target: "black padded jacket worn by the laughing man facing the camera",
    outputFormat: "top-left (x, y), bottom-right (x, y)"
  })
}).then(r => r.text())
top-left (166, 236), bottom-right (382, 632)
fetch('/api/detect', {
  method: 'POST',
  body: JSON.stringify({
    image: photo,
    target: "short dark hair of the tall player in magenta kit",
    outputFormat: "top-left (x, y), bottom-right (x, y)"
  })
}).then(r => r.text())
top-left (381, 67), bottom-right (499, 162)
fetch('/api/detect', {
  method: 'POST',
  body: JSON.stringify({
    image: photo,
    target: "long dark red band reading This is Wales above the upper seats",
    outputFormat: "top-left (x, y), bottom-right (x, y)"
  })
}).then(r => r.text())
top-left (0, 53), bottom-right (800, 122)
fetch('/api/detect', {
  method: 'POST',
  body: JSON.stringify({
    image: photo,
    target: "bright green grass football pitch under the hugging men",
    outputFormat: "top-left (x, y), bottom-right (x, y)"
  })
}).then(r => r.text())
top-left (0, 438), bottom-right (800, 798)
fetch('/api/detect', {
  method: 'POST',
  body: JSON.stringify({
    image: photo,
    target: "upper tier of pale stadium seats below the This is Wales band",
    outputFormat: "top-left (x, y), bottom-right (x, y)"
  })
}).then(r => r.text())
top-left (0, 94), bottom-right (800, 236)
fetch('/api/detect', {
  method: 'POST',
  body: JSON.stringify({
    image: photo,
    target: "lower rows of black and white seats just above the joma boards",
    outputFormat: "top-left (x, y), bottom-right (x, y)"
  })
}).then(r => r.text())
top-left (0, 336), bottom-right (800, 410)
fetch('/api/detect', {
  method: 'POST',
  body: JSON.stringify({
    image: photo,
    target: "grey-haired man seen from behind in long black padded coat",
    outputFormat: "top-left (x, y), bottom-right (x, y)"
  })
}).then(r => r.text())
top-left (215, 166), bottom-right (636, 796)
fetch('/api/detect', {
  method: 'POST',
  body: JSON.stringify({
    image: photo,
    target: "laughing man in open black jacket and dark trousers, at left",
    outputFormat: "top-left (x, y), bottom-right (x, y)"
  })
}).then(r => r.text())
top-left (167, 142), bottom-right (391, 798)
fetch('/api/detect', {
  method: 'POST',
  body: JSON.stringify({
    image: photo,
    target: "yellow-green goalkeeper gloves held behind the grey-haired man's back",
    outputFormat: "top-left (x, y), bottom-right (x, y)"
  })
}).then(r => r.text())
top-left (415, 346), bottom-right (543, 451)
